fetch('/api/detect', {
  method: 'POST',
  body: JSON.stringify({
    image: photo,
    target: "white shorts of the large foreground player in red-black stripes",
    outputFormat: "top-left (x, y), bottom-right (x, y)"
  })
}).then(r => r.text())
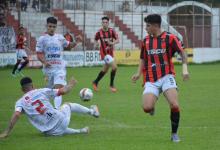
top-left (143, 74), bottom-right (177, 97)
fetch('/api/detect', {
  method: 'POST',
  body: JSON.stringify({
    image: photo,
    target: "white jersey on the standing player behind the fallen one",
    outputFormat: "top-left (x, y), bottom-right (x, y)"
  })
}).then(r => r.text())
top-left (36, 34), bottom-right (69, 71)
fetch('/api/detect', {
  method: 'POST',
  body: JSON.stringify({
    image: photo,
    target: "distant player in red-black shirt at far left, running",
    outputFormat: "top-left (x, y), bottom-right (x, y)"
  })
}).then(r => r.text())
top-left (12, 26), bottom-right (29, 77)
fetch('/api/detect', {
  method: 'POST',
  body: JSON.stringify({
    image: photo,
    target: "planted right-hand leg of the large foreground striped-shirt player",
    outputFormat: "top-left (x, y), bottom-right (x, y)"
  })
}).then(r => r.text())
top-left (162, 75), bottom-right (180, 142)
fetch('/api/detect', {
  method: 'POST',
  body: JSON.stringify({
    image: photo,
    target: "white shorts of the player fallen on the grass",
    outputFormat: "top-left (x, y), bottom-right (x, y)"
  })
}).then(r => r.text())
top-left (44, 104), bottom-right (71, 135)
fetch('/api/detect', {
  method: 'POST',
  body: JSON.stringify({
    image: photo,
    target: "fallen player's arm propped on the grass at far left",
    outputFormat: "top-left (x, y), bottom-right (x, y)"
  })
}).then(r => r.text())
top-left (0, 111), bottom-right (21, 138)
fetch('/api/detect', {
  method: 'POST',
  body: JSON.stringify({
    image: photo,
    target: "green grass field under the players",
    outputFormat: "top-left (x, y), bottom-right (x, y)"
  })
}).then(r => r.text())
top-left (0, 63), bottom-right (220, 150)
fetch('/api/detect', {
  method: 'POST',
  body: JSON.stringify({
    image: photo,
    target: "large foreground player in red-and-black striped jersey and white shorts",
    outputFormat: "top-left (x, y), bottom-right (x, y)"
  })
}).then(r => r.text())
top-left (132, 14), bottom-right (189, 142)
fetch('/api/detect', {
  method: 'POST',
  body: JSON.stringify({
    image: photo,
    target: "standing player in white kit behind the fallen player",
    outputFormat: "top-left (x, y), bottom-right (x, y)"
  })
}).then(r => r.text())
top-left (36, 17), bottom-right (81, 109)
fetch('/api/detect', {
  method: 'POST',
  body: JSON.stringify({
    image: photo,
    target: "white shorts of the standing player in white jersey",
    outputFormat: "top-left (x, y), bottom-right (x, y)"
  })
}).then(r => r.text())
top-left (44, 69), bottom-right (67, 88)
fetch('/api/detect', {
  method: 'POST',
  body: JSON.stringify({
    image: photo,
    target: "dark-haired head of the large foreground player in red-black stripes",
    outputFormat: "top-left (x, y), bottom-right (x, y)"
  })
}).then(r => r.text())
top-left (144, 14), bottom-right (161, 34)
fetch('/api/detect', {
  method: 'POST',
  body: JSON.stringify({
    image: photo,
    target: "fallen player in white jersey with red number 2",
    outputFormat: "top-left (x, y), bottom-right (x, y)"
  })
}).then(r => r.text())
top-left (0, 77), bottom-right (100, 138)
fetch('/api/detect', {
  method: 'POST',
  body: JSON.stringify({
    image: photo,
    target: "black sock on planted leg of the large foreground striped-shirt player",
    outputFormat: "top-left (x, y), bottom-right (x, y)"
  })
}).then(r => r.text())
top-left (170, 109), bottom-right (180, 133)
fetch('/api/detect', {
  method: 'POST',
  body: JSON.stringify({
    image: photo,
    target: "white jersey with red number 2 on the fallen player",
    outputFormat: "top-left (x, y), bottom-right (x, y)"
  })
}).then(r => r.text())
top-left (15, 88), bottom-right (64, 132)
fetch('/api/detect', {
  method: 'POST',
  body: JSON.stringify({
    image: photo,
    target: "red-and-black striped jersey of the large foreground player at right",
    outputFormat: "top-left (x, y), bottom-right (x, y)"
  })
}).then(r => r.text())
top-left (140, 32), bottom-right (183, 82)
